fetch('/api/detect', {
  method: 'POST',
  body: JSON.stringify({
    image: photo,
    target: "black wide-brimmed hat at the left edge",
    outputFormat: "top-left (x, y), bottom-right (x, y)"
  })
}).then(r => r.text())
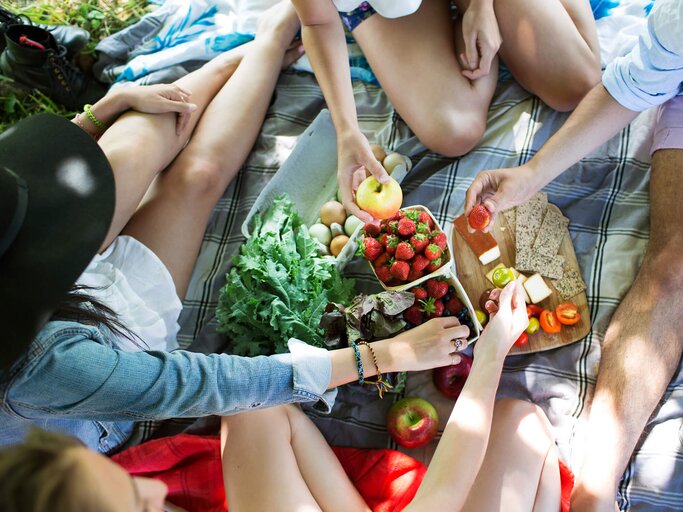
top-left (0, 114), bottom-right (115, 370)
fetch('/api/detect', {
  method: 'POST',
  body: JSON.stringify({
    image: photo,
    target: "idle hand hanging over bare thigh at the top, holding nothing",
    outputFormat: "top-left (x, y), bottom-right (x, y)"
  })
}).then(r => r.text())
top-left (460, 0), bottom-right (503, 80)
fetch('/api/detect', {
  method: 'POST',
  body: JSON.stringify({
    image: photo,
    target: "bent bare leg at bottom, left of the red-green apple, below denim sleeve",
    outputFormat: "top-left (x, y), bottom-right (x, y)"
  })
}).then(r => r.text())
top-left (221, 405), bottom-right (369, 512)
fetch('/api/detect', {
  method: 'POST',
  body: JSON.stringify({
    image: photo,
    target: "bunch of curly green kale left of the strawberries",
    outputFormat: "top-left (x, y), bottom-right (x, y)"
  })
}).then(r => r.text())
top-left (216, 196), bottom-right (354, 356)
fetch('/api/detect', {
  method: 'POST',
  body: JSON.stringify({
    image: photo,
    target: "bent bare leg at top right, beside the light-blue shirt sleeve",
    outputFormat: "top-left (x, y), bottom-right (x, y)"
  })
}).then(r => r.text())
top-left (456, 0), bottom-right (600, 112)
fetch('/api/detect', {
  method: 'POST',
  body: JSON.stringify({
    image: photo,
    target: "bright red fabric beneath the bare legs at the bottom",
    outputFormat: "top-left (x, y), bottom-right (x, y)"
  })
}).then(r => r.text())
top-left (112, 434), bottom-right (574, 512)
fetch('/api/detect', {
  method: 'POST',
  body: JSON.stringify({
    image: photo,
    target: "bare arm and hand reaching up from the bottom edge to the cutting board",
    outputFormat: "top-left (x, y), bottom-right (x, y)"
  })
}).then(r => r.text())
top-left (406, 282), bottom-right (529, 512)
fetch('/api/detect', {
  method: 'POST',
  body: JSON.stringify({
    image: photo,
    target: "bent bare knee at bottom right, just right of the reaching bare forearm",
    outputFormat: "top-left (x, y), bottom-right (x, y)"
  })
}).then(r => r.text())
top-left (458, 399), bottom-right (560, 512)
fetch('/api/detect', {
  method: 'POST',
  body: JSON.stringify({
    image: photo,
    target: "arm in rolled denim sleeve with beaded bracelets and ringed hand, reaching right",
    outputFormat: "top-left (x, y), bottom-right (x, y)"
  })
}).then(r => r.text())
top-left (7, 317), bottom-right (469, 421)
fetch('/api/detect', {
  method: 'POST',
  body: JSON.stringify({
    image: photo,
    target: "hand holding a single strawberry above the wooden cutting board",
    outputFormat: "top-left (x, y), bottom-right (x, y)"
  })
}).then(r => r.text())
top-left (465, 165), bottom-right (542, 231)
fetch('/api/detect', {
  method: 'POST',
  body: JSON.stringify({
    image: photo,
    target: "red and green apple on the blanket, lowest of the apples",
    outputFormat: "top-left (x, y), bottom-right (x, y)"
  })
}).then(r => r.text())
top-left (387, 397), bottom-right (439, 448)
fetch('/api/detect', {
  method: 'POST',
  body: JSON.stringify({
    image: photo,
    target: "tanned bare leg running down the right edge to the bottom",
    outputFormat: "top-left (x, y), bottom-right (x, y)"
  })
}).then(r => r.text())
top-left (572, 149), bottom-right (683, 512)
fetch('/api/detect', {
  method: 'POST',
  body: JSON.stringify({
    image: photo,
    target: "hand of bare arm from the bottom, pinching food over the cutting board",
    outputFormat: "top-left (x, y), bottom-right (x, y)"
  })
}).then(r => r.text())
top-left (474, 280), bottom-right (529, 360)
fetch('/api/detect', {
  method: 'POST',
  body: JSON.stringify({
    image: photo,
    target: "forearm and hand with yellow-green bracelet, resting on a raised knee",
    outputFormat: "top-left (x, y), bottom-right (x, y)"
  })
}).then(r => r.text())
top-left (73, 84), bottom-right (197, 137)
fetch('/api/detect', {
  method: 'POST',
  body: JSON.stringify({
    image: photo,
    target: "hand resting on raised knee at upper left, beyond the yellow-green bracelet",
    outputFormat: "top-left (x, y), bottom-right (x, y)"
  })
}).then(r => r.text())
top-left (119, 84), bottom-right (197, 135)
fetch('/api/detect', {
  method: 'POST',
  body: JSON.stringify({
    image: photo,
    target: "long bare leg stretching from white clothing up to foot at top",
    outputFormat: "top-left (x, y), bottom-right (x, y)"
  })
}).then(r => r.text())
top-left (122, 1), bottom-right (300, 299)
